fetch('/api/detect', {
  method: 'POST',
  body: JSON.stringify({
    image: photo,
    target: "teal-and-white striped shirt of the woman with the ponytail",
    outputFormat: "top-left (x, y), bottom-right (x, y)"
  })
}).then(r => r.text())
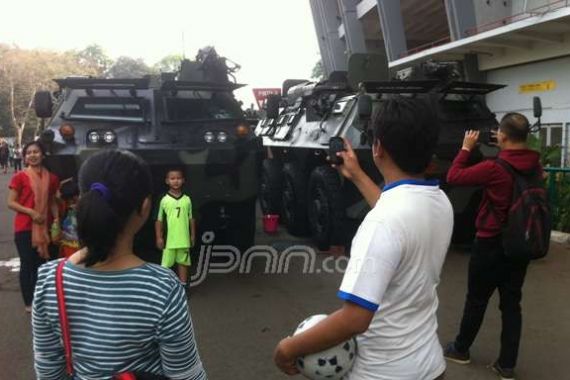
top-left (32, 260), bottom-right (206, 380)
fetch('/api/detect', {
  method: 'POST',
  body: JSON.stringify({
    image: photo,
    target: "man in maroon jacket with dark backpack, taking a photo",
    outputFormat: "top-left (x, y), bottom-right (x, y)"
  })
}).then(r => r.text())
top-left (444, 113), bottom-right (550, 380)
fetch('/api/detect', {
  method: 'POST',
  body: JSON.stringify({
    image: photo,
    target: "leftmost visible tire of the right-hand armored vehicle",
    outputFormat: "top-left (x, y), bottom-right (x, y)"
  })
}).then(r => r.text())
top-left (259, 159), bottom-right (283, 215)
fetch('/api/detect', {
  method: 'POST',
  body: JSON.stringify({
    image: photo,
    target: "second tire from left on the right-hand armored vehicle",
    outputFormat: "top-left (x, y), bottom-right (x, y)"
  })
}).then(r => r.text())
top-left (282, 163), bottom-right (309, 236)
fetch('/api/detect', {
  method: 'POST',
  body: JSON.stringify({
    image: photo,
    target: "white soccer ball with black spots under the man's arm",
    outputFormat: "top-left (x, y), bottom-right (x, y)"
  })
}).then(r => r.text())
top-left (293, 314), bottom-right (356, 380)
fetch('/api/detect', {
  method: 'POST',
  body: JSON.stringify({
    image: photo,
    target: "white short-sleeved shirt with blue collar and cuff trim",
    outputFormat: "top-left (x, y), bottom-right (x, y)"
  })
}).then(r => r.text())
top-left (338, 180), bottom-right (453, 380)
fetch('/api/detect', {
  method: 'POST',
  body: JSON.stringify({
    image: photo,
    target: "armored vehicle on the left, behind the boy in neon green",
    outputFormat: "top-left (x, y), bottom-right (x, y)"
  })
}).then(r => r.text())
top-left (35, 48), bottom-right (261, 252)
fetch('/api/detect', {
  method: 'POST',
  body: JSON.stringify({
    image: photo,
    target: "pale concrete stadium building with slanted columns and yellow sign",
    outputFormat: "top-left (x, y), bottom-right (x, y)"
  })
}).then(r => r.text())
top-left (309, 0), bottom-right (570, 166)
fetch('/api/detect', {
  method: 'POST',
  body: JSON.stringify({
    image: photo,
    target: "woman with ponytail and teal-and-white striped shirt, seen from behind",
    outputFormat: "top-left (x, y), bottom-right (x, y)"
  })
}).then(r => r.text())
top-left (32, 150), bottom-right (206, 380)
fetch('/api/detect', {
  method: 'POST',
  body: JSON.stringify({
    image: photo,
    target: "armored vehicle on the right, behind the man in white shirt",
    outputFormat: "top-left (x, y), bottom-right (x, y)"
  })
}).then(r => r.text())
top-left (255, 58), bottom-right (504, 250)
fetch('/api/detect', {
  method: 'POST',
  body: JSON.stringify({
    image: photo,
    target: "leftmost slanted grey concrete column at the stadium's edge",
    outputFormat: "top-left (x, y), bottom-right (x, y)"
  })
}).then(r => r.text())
top-left (310, 0), bottom-right (348, 76)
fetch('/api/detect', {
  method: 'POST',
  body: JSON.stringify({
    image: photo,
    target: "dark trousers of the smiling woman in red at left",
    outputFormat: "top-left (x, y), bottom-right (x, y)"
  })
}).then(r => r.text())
top-left (14, 231), bottom-right (45, 306)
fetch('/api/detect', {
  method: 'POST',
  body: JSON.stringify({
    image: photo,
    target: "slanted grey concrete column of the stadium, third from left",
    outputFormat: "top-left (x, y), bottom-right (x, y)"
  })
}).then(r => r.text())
top-left (376, 0), bottom-right (408, 61)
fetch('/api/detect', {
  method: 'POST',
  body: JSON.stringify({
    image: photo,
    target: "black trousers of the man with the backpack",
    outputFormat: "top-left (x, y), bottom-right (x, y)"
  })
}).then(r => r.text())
top-left (455, 237), bottom-right (528, 368)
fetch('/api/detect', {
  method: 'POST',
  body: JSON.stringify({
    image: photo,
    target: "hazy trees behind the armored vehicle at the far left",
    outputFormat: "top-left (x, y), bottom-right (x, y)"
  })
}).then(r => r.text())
top-left (0, 44), bottom-right (182, 141)
